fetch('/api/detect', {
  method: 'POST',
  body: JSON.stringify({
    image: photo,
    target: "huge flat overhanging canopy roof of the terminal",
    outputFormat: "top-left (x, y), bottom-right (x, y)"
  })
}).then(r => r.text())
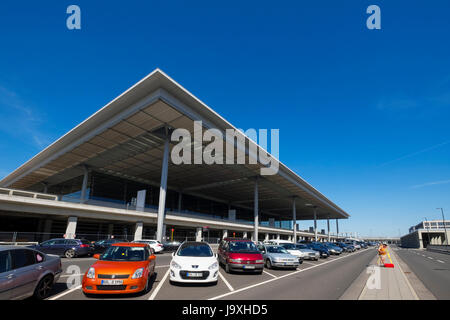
top-left (0, 69), bottom-right (349, 220)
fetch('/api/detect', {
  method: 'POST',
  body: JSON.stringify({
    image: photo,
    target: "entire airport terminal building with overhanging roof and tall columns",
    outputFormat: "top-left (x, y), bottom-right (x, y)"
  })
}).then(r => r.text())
top-left (0, 69), bottom-right (349, 241)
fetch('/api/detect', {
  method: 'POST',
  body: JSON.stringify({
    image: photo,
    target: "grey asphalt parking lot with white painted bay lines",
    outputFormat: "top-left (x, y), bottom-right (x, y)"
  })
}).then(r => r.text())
top-left (44, 247), bottom-right (376, 300)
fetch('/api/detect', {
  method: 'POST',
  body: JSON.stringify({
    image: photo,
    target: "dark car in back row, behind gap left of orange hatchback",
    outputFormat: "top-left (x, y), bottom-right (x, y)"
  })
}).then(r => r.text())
top-left (28, 238), bottom-right (94, 258)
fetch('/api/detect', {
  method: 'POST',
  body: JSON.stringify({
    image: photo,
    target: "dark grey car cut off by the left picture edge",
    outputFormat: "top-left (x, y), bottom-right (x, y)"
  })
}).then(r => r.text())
top-left (0, 246), bottom-right (62, 300)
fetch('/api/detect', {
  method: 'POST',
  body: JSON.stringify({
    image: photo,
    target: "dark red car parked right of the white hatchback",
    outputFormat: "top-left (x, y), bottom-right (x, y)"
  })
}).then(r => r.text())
top-left (217, 238), bottom-right (264, 274)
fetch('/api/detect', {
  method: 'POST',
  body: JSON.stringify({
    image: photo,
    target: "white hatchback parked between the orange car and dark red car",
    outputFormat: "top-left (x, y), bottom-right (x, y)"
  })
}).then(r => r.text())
top-left (170, 241), bottom-right (219, 283)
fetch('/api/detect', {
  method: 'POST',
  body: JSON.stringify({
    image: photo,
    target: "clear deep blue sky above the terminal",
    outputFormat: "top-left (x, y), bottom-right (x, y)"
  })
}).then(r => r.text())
top-left (0, 0), bottom-right (450, 236)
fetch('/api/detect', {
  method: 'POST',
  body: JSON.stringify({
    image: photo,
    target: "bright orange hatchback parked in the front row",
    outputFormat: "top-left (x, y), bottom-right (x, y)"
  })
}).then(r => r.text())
top-left (82, 243), bottom-right (156, 295)
